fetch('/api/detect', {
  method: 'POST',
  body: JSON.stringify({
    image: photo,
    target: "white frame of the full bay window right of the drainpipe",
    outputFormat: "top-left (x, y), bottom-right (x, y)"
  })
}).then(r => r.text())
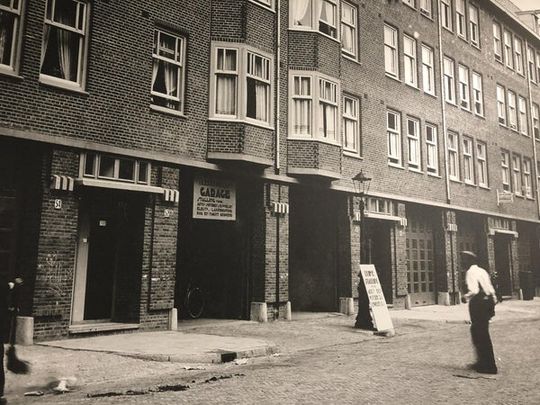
top-left (289, 71), bottom-right (342, 146)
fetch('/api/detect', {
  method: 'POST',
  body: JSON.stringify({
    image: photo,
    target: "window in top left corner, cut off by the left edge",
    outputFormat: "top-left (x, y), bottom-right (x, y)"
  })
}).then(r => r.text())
top-left (0, 0), bottom-right (22, 73)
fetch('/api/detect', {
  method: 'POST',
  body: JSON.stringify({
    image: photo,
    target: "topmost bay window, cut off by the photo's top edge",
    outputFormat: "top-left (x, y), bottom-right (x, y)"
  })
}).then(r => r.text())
top-left (289, 0), bottom-right (337, 38)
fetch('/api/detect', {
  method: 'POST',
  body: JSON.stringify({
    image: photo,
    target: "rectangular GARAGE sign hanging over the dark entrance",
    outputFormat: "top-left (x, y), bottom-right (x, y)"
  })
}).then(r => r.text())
top-left (193, 177), bottom-right (236, 221)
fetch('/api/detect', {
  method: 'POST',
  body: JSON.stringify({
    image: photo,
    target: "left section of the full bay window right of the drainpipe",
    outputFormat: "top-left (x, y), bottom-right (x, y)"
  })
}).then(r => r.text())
top-left (291, 75), bottom-right (313, 136)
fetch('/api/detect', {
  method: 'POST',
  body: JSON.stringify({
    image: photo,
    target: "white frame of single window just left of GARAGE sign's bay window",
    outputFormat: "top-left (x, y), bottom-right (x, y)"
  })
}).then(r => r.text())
top-left (150, 28), bottom-right (186, 114)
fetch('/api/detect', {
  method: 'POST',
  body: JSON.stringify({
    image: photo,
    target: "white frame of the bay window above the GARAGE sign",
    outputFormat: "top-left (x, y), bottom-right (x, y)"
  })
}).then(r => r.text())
top-left (209, 41), bottom-right (274, 129)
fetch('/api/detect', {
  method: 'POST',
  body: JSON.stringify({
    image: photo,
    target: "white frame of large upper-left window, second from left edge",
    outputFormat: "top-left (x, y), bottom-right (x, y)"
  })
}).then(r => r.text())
top-left (40, 0), bottom-right (90, 91)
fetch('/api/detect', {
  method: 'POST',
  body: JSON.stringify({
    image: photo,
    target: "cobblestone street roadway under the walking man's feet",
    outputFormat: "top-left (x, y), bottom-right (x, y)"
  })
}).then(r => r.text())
top-left (10, 308), bottom-right (540, 405)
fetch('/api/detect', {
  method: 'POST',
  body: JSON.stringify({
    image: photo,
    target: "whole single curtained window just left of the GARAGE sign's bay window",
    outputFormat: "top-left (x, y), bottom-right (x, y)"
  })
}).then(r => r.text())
top-left (151, 29), bottom-right (185, 112)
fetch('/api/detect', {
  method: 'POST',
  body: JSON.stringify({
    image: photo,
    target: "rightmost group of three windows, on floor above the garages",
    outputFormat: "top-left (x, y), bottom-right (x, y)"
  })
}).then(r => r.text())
top-left (501, 150), bottom-right (533, 198)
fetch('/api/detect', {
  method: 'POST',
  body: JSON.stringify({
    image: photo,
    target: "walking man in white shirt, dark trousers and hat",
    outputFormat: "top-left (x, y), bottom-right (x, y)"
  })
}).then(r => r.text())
top-left (461, 251), bottom-right (497, 374)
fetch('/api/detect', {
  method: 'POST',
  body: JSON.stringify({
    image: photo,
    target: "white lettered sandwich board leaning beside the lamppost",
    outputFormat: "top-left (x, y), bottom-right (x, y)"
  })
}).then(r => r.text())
top-left (360, 264), bottom-right (394, 331)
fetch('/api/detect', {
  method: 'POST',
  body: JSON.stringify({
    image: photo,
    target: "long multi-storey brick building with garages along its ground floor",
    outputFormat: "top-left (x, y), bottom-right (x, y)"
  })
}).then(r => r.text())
top-left (0, 0), bottom-right (540, 339)
